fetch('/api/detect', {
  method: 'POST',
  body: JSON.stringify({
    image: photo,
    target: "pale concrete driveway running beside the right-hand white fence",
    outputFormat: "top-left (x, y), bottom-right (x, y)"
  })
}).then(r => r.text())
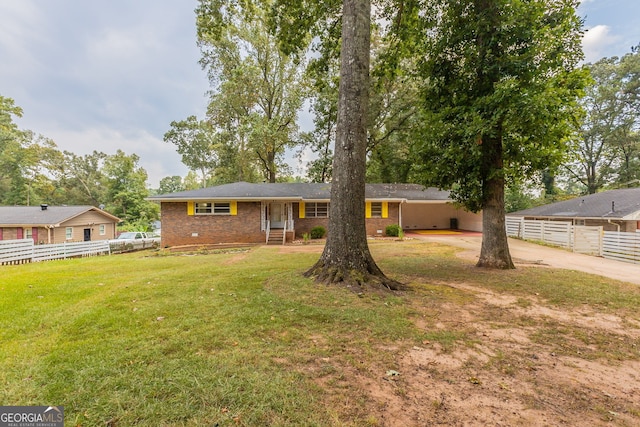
top-left (406, 232), bottom-right (640, 285)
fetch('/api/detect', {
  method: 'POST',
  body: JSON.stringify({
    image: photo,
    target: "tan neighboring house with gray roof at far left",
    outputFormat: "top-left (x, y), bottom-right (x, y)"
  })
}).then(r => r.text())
top-left (0, 205), bottom-right (120, 244)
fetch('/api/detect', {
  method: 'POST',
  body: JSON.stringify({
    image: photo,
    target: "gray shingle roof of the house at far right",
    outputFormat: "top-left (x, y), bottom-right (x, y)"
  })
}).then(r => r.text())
top-left (508, 188), bottom-right (640, 220)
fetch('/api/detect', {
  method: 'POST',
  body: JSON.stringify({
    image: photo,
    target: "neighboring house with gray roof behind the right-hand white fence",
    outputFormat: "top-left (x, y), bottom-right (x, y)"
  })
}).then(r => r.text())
top-left (507, 188), bottom-right (640, 231)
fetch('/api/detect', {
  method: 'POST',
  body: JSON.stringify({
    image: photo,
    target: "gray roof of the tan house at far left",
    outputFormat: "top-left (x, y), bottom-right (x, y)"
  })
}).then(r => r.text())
top-left (0, 206), bottom-right (118, 226)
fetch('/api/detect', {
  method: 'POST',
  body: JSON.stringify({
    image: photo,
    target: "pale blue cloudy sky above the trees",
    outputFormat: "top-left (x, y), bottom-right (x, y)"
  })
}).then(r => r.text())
top-left (0, 0), bottom-right (640, 187)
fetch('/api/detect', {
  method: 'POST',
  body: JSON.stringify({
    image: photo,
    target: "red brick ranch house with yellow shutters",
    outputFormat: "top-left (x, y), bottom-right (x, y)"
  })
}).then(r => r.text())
top-left (148, 182), bottom-right (482, 246)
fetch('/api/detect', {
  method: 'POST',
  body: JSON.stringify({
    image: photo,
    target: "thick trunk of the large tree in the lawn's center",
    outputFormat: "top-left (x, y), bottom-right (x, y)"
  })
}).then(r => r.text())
top-left (306, 0), bottom-right (400, 289)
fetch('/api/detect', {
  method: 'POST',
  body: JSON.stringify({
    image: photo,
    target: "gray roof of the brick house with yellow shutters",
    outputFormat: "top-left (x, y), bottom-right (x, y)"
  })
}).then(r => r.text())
top-left (148, 182), bottom-right (449, 202)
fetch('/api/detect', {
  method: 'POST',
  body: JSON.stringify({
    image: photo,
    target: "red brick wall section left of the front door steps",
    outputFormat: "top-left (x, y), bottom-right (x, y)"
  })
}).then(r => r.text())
top-left (161, 202), bottom-right (265, 246)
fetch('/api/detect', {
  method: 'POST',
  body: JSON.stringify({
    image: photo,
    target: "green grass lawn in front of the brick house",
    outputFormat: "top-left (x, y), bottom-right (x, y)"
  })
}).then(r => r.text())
top-left (0, 242), bottom-right (640, 426)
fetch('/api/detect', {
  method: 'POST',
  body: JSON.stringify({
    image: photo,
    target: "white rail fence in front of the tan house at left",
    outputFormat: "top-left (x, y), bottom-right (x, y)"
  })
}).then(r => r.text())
top-left (0, 239), bottom-right (111, 265)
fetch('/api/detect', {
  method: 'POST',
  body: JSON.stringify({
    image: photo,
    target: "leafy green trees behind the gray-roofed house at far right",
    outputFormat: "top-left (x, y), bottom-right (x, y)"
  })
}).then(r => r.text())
top-left (506, 45), bottom-right (640, 211)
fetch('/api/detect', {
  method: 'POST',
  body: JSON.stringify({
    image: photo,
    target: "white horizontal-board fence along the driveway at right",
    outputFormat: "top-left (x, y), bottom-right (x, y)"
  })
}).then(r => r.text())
top-left (506, 217), bottom-right (640, 264)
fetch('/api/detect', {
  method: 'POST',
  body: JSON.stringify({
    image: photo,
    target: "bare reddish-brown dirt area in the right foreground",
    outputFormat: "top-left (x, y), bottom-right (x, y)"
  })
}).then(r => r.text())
top-left (282, 241), bottom-right (640, 427)
